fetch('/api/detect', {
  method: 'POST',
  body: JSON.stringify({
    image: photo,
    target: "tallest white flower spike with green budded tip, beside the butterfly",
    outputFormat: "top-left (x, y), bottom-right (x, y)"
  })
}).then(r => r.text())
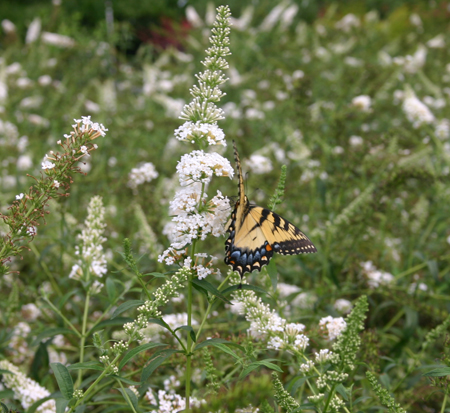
top-left (159, 6), bottom-right (234, 276)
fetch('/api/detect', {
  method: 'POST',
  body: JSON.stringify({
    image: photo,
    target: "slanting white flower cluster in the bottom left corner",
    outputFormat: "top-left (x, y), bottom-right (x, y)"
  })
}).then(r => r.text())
top-left (0, 360), bottom-right (56, 413)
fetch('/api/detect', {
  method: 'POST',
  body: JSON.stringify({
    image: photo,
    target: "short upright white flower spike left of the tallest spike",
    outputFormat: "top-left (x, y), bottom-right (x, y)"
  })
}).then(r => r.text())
top-left (69, 196), bottom-right (106, 292)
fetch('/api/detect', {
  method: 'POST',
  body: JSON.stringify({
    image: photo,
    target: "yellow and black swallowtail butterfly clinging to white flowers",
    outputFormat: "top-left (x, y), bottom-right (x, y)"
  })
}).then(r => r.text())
top-left (225, 142), bottom-right (317, 278)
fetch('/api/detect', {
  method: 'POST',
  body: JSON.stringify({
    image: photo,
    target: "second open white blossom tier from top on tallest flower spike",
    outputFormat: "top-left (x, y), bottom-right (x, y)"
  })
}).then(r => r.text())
top-left (177, 151), bottom-right (234, 186)
